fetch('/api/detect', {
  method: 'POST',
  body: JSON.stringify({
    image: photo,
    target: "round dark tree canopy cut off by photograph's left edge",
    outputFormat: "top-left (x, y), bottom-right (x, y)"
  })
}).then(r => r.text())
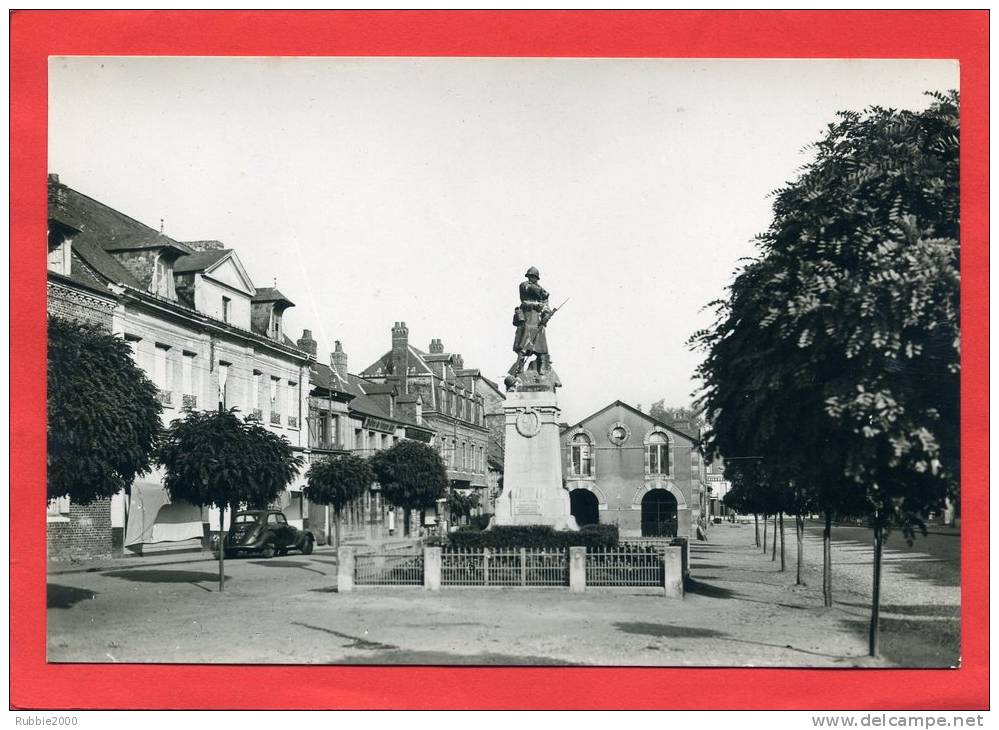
top-left (47, 317), bottom-right (161, 504)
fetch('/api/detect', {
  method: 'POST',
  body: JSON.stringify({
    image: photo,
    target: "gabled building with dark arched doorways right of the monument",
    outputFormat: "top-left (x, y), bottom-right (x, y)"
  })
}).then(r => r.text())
top-left (561, 400), bottom-right (703, 538)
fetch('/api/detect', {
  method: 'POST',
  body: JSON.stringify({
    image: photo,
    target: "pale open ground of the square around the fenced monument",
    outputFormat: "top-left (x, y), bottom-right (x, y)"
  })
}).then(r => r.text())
top-left (48, 524), bottom-right (959, 667)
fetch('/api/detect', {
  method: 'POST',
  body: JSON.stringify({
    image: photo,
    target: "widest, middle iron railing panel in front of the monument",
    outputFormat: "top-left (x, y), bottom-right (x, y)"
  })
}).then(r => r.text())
top-left (441, 548), bottom-right (569, 587)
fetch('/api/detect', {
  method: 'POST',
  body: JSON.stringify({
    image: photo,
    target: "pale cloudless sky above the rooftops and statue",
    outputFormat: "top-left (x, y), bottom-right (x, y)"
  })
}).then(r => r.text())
top-left (49, 57), bottom-right (958, 423)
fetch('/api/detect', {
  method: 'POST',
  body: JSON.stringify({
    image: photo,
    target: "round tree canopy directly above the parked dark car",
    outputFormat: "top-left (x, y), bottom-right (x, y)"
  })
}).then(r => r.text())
top-left (156, 410), bottom-right (303, 508)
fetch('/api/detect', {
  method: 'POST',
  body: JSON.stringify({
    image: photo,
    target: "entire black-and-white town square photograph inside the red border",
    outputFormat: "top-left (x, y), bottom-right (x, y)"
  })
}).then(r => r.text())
top-left (45, 56), bottom-right (961, 668)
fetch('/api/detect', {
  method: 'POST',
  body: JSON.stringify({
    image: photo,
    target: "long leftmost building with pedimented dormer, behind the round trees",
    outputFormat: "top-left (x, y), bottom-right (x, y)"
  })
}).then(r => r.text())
top-left (49, 176), bottom-right (312, 554)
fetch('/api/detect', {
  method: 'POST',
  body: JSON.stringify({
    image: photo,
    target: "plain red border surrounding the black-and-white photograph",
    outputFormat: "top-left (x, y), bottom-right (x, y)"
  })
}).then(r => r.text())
top-left (10, 10), bottom-right (989, 709)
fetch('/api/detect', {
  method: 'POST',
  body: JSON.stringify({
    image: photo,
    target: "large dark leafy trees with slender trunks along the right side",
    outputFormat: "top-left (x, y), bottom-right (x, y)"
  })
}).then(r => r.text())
top-left (693, 92), bottom-right (960, 655)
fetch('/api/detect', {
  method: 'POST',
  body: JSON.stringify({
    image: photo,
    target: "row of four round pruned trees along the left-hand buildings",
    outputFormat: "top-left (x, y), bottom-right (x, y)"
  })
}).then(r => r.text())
top-left (47, 317), bottom-right (452, 590)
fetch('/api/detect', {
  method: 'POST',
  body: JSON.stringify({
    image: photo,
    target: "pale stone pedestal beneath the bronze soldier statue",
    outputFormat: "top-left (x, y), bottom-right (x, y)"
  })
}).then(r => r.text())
top-left (492, 384), bottom-right (579, 530)
